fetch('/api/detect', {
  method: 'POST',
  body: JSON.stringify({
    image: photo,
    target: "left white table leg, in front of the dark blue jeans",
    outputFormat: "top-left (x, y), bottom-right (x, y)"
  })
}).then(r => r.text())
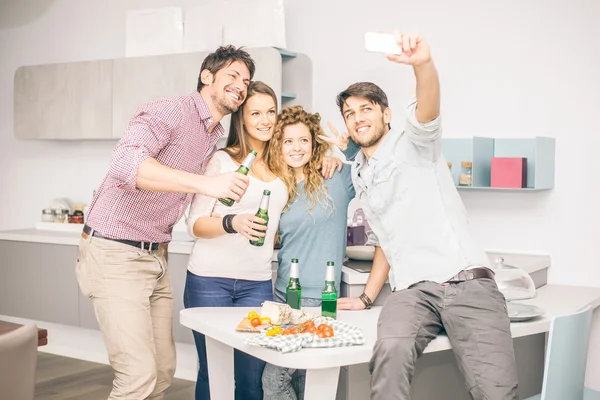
top-left (205, 336), bottom-right (234, 400)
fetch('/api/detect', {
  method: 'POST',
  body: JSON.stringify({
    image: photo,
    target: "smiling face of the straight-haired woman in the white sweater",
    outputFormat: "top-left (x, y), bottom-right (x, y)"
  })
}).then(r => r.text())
top-left (243, 93), bottom-right (277, 142)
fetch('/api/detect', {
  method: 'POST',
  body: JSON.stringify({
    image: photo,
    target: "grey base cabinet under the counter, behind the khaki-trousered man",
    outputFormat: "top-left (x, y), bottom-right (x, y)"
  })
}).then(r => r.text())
top-left (0, 240), bottom-right (194, 343)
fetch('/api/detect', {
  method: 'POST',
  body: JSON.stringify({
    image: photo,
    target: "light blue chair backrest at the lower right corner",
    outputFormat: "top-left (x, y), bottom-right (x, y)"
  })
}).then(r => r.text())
top-left (541, 307), bottom-right (592, 400)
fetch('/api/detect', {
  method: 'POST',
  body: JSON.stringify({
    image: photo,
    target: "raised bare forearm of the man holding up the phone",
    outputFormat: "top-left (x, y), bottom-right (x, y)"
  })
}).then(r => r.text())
top-left (414, 60), bottom-right (440, 124)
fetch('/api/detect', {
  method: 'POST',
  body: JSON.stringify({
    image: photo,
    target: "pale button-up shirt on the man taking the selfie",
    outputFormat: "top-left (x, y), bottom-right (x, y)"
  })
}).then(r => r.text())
top-left (345, 100), bottom-right (489, 290)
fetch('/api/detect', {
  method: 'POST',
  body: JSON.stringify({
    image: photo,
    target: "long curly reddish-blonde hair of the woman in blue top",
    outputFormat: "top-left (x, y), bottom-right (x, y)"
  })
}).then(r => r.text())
top-left (269, 106), bottom-right (333, 212)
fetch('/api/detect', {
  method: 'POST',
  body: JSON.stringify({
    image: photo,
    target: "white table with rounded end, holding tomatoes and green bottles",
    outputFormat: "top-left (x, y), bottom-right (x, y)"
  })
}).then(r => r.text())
top-left (180, 285), bottom-right (600, 399)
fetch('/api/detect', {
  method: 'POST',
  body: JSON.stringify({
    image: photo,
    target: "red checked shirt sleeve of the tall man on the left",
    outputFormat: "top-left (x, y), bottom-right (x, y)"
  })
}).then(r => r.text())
top-left (109, 99), bottom-right (183, 191)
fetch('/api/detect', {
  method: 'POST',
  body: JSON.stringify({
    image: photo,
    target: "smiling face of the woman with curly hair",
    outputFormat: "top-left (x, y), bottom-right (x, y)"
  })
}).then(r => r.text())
top-left (281, 123), bottom-right (312, 176)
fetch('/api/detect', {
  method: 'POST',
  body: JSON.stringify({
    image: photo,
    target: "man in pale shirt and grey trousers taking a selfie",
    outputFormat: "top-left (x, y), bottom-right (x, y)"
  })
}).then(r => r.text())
top-left (328, 34), bottom-right (517, 400)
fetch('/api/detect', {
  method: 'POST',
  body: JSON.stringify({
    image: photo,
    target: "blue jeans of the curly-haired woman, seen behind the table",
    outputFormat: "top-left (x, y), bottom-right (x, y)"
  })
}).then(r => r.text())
top-left (262, 290), bottom-right (321, 400)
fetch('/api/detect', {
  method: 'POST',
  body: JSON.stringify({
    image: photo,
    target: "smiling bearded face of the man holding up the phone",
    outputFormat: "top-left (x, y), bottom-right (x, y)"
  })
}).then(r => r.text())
top-left (342, 96), bottom-right (391, 149)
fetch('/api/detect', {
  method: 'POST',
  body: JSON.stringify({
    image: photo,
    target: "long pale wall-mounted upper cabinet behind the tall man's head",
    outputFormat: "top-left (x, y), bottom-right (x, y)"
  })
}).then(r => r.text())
top-left (14, 47), bottom-right (313, 144)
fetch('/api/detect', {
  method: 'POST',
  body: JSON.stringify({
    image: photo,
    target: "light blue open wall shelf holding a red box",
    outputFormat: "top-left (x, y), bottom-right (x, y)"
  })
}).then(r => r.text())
top-left (442, 136), bottom-right (555, 192)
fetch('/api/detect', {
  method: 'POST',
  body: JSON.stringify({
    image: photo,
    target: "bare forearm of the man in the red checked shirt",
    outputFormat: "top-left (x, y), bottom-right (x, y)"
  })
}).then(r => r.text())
top-left (136, 158), bottom-right (206, 193)
